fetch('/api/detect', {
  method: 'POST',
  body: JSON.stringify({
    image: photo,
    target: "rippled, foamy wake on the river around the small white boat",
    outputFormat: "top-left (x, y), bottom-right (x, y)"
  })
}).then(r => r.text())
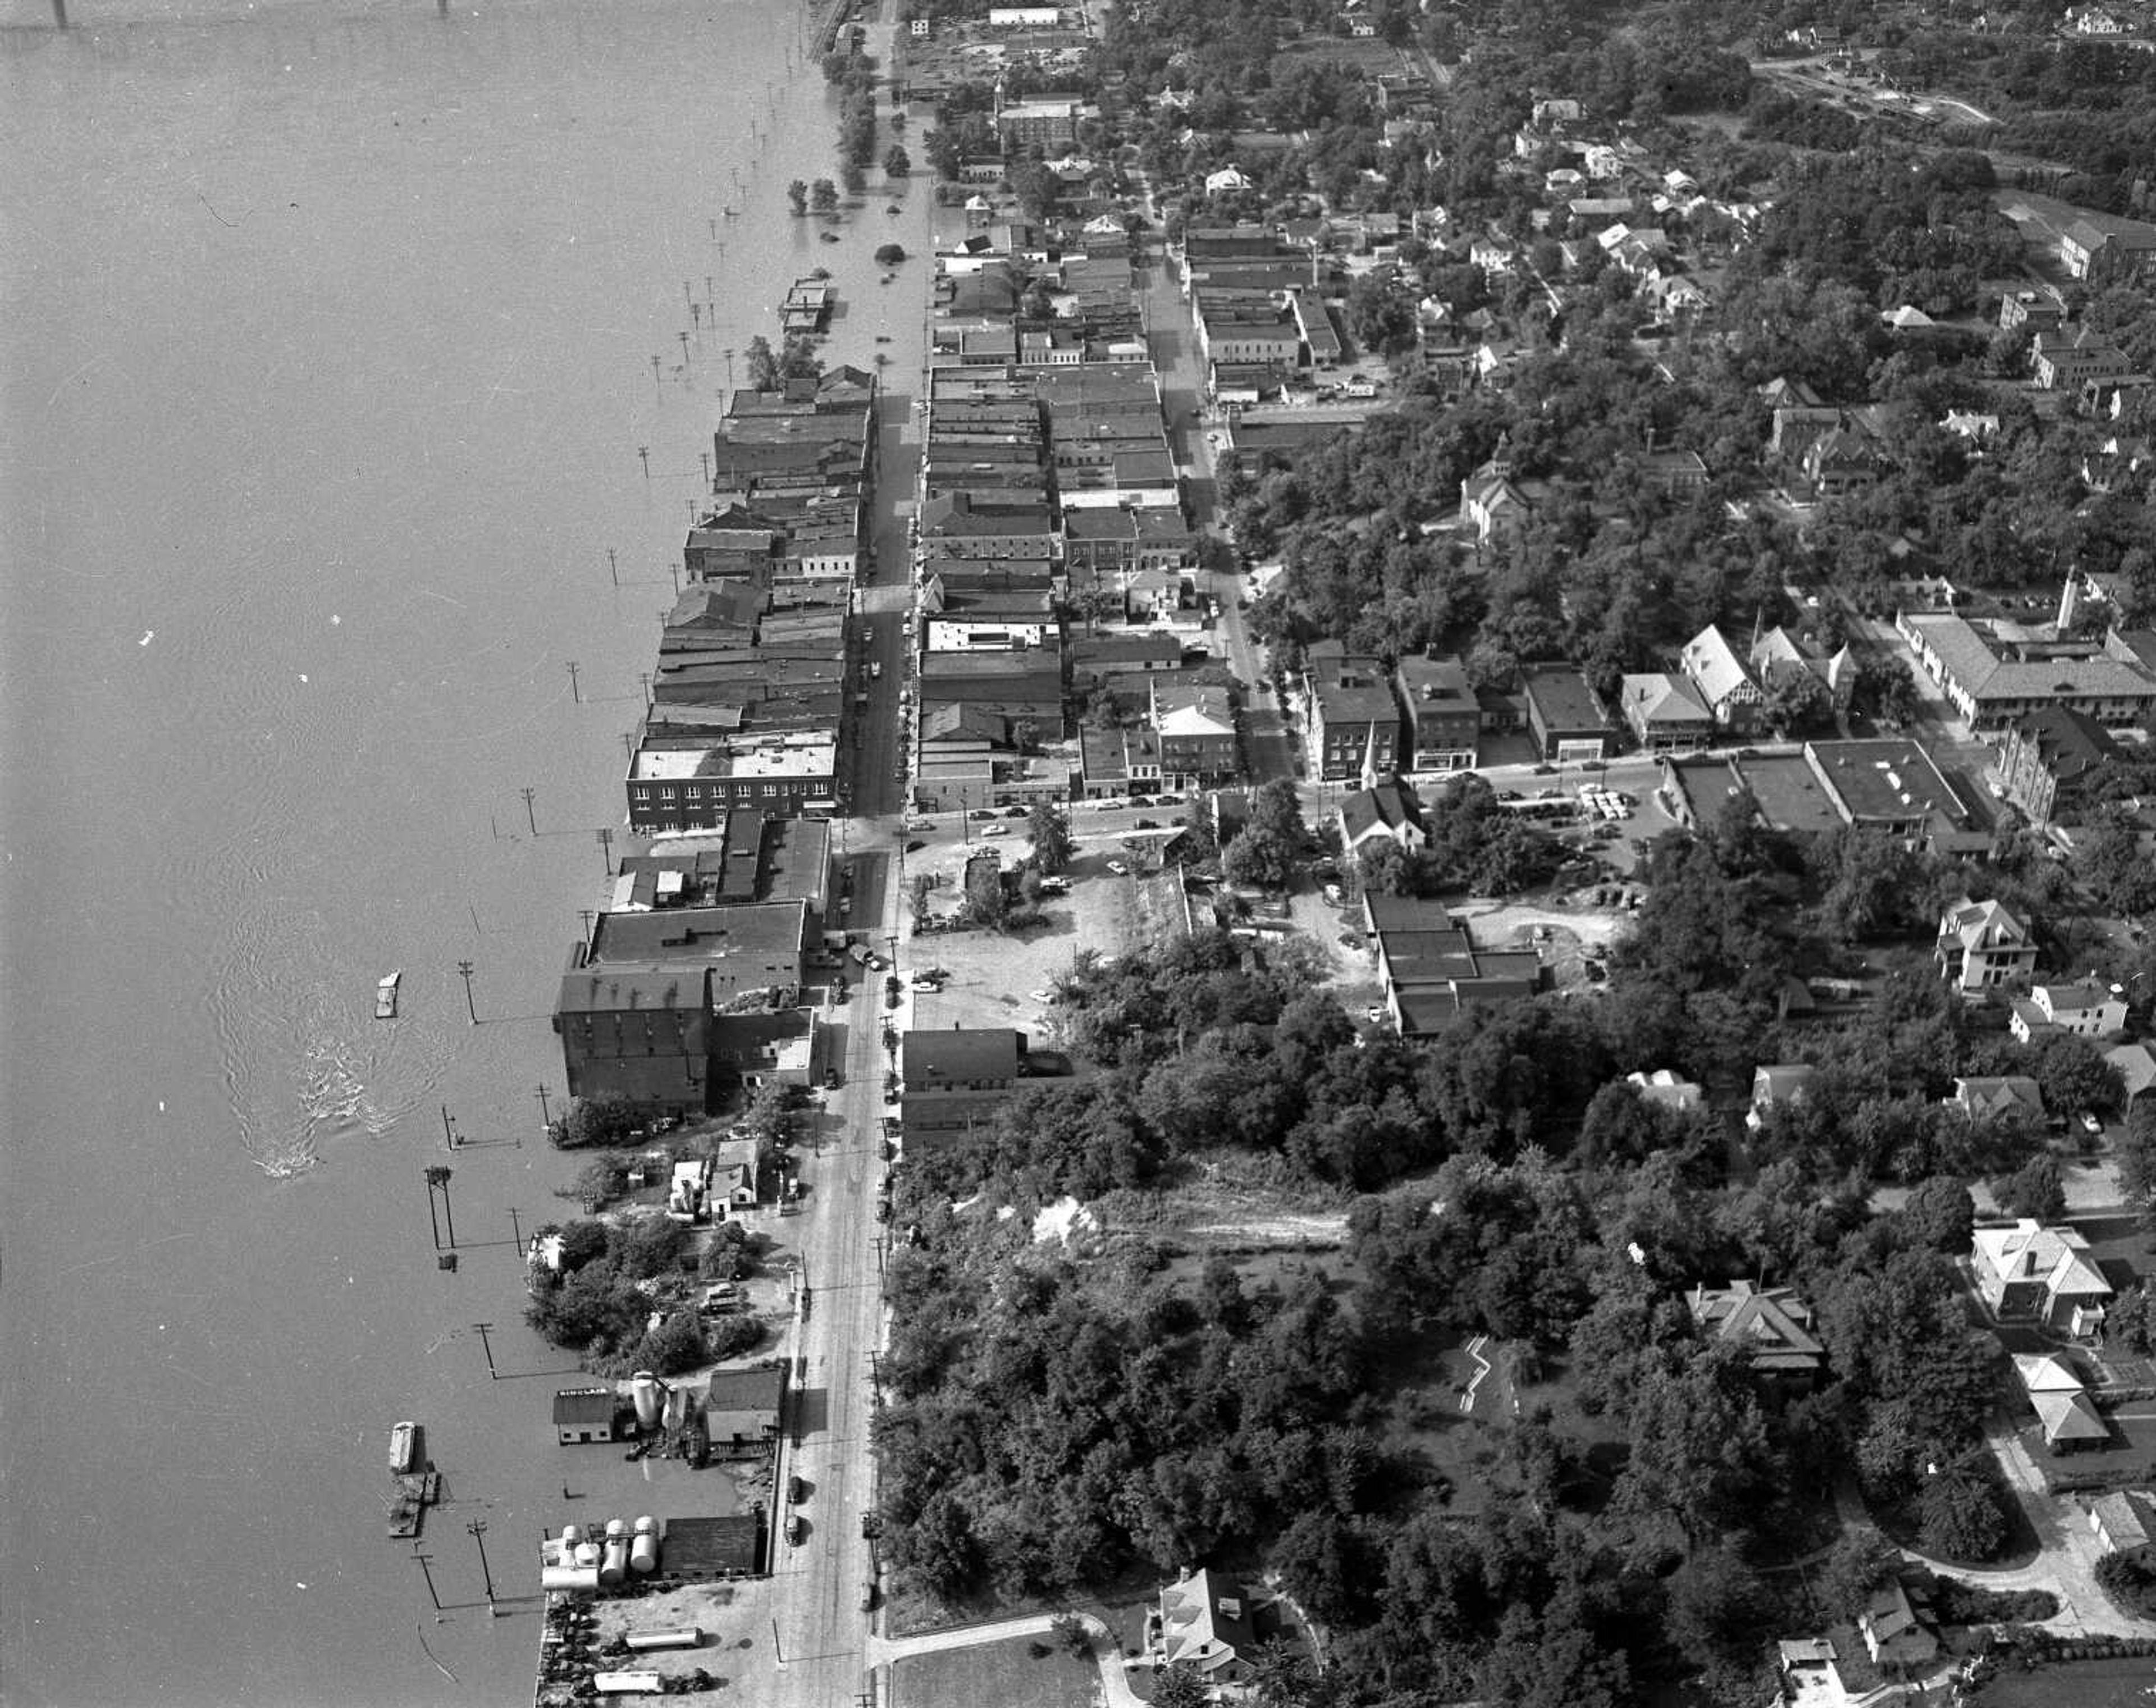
top-left (209, 906), bottom-right (461, 1180)
